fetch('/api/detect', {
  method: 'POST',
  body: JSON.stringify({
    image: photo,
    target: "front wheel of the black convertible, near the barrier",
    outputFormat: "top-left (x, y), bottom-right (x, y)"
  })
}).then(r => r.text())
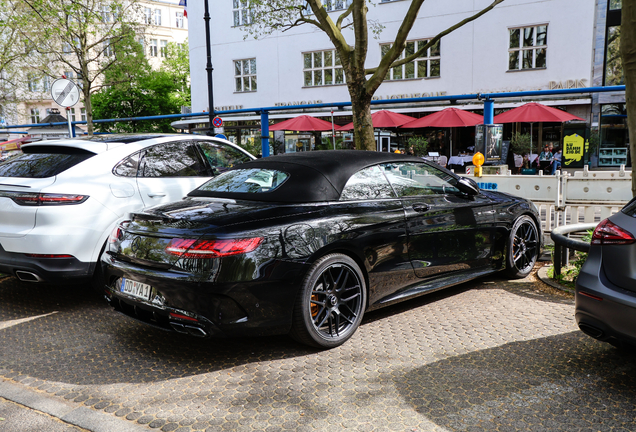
top-left (506, 216), bottom-right (539, 279)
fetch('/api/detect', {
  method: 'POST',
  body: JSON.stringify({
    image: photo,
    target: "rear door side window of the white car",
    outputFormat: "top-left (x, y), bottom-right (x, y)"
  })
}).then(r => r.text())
top-left (140, 141), bottom-right (209, 177)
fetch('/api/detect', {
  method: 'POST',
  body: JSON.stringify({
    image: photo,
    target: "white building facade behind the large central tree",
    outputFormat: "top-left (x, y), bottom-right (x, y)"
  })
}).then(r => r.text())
top-left (184, 0), bottom-right (624, 167)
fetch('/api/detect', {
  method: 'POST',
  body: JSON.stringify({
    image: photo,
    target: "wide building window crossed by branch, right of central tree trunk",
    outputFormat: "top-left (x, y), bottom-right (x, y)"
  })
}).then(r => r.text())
top-left (380, 39), bottom-right (441, 80)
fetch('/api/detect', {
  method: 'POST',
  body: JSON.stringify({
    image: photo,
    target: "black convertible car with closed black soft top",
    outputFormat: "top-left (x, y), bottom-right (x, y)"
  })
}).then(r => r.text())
top-left (102, 150), bottom-right (541, 348)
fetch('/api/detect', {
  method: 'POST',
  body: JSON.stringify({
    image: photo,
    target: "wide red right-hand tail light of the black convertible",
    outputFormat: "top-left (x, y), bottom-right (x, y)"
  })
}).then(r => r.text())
top-left (166, 237), bottom-right (263, 258)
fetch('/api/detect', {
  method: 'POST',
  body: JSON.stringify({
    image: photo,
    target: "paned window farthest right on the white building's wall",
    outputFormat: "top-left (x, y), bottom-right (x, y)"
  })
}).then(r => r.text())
top-left (508, 25), bottom-right (548, 71)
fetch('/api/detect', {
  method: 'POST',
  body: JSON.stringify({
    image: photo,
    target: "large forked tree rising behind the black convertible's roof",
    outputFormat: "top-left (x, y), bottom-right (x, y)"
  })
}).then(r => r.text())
top-left (245, 0), bottom-right (503, 150)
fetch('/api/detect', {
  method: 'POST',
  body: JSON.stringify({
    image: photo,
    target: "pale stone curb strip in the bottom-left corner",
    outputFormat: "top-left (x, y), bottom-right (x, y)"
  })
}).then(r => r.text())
top-left (0, 379), bottom-right (149, 432)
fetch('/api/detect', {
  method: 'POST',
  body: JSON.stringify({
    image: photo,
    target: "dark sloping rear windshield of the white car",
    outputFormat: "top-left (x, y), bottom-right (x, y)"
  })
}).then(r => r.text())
top-left (0, 148), bottom-right (95, 178)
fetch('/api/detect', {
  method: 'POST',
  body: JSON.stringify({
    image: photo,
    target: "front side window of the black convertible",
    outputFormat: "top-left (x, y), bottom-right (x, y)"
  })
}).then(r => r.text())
top-left (383, 162), bottom-right (459, 197)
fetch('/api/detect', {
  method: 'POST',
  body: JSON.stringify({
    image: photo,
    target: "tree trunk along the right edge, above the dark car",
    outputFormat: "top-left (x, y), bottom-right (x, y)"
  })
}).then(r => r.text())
top-left (620, 0), bottom-right (636, 196)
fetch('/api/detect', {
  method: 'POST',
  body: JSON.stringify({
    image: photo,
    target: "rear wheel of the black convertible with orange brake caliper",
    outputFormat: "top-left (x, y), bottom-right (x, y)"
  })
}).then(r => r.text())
top-left (290, 254), bottom-right (367, 349)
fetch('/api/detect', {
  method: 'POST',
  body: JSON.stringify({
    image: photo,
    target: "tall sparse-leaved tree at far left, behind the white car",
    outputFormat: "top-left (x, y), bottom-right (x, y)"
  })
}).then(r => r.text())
top-left (10, 0), bottom-right (142, 135)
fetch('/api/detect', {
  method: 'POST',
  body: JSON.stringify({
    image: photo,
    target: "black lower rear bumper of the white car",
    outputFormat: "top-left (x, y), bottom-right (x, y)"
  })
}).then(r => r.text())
top-left (0, 245), bottom-right (95, 284)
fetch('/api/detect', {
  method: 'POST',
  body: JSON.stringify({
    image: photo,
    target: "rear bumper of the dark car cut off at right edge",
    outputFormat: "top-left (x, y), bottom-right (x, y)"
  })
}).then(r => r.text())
top-left (574, 248), bottom-right (636, 345)
